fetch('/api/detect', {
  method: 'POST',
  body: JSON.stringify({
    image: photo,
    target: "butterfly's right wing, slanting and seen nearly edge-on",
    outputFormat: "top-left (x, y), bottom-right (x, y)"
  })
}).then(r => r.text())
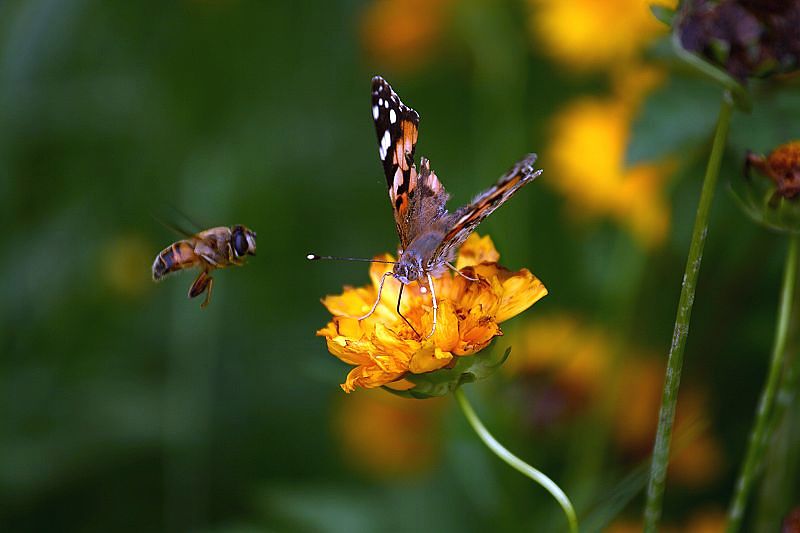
top-left (429, 154), bottom-right (542, 271)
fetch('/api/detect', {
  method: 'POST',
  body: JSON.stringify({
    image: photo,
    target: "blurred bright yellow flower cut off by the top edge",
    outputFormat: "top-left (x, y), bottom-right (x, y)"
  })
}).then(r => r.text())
top-left (528, 0), bottom-right (675, 70)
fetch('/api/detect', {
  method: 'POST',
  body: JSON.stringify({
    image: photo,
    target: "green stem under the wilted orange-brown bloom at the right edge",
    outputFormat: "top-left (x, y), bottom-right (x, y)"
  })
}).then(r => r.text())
top-left (727, 235), bottom-right (798, 533)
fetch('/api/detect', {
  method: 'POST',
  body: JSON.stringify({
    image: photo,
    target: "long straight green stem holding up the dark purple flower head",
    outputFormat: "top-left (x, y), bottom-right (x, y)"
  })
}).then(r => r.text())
top-left (644, 91), bottom-right (733, 533)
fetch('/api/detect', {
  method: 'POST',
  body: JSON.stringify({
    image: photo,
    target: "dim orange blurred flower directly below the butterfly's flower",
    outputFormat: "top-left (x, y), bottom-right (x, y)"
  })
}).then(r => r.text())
top-left (334, 384), bottom-right (444, 477)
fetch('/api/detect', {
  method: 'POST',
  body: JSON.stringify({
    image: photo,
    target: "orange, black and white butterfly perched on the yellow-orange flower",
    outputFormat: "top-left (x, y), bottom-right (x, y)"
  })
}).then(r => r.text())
top-left (309, 76), bottom-right (542, 338)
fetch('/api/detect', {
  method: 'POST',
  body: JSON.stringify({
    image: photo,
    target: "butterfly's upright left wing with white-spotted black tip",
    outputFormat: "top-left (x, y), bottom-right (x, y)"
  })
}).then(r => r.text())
top-left (372, 76), bottom-right (419, 250)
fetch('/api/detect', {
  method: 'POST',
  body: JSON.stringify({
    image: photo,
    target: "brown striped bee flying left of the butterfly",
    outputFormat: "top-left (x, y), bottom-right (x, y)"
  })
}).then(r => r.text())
top-left (153, 224), bottom-right (256, 308)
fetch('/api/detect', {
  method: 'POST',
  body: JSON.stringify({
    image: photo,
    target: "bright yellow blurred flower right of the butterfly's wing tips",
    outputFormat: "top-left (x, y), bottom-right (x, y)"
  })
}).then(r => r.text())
top-left (547, 69), bottom-right (672, 246)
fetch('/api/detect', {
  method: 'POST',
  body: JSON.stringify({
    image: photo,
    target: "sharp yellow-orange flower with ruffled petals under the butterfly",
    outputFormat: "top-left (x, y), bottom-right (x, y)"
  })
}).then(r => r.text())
top-left (317, 234), bottom-right (547, 392)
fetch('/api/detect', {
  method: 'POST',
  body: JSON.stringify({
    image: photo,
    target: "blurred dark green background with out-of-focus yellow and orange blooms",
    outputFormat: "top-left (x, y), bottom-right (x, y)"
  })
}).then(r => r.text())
top-left (0, 0), bottom-right (800, 533)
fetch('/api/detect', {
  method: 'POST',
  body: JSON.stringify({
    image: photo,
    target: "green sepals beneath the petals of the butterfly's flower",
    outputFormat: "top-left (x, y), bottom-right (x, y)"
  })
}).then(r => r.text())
top-left (383, 347), bottom-right (511, 400)
